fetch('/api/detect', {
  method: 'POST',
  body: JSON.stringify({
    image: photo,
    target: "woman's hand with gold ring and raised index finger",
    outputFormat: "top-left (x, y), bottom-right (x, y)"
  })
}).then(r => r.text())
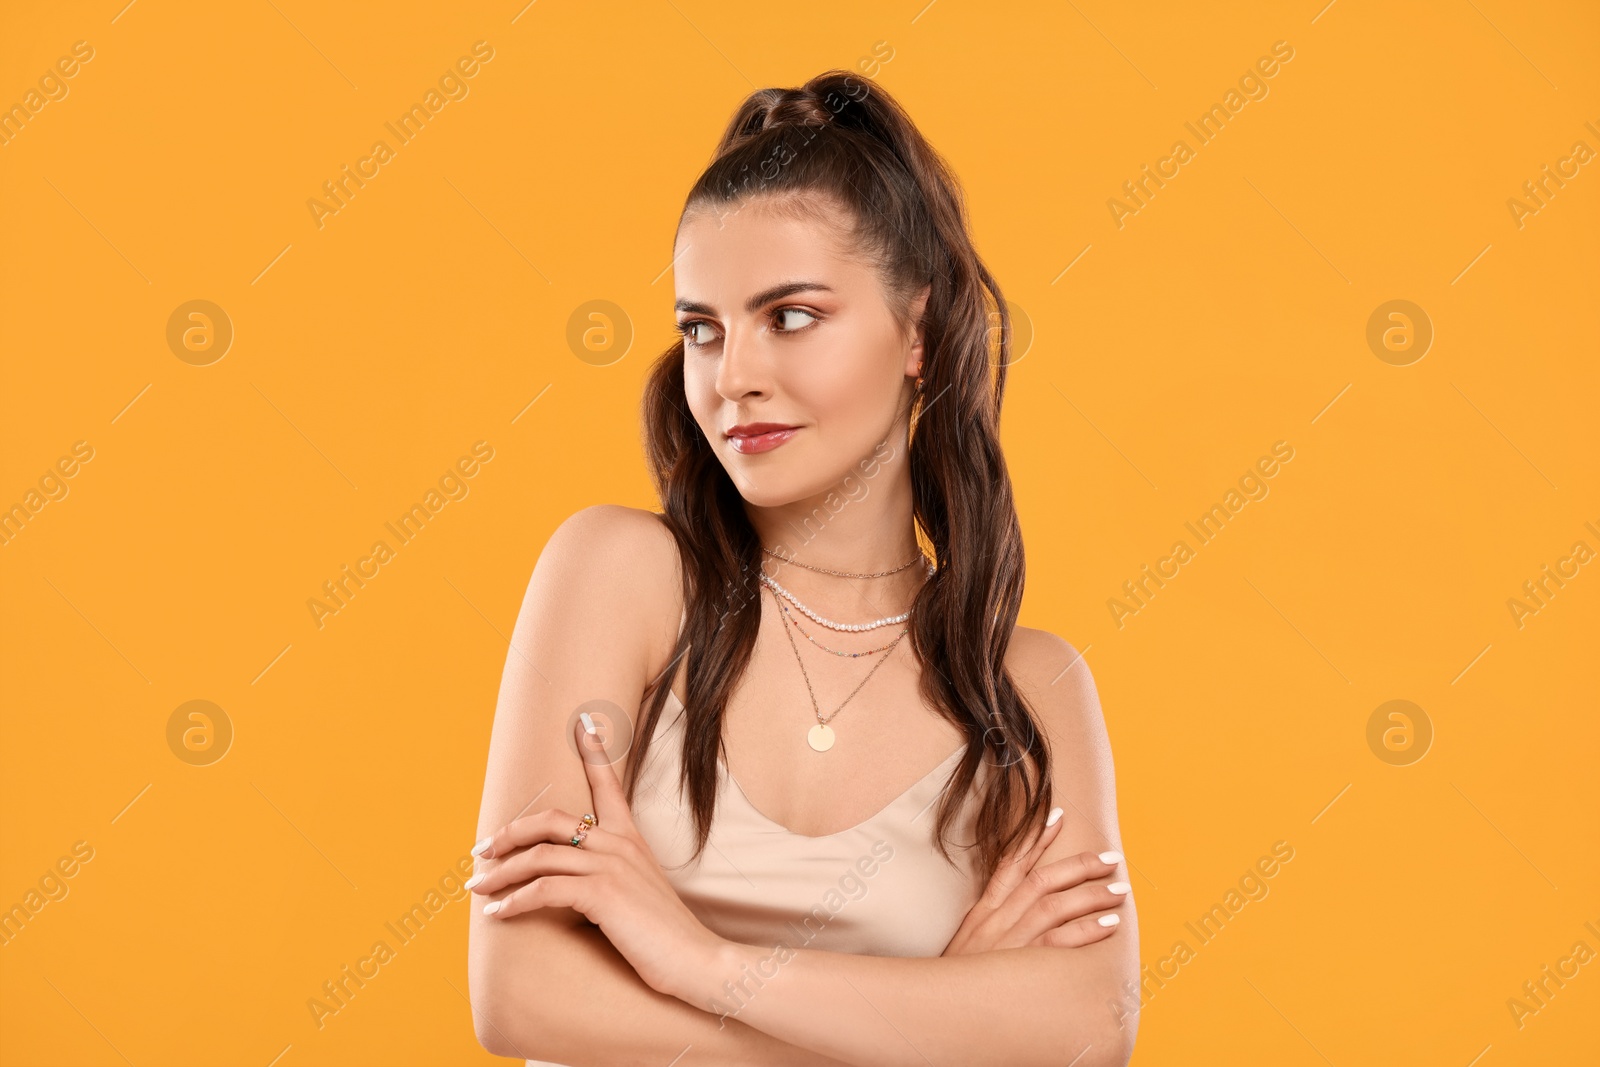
top-left (466, 720), bottom-right (730, 997)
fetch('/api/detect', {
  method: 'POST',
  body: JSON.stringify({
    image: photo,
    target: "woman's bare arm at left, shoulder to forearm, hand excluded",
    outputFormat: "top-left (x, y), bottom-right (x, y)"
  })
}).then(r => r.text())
top-left (467, 507), bottom-right (837, 1067)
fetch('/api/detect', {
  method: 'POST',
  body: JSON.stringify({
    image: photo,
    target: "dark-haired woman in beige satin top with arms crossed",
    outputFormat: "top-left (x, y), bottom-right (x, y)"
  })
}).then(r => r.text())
top-left (469, 70), bottom-right (1138, 1067)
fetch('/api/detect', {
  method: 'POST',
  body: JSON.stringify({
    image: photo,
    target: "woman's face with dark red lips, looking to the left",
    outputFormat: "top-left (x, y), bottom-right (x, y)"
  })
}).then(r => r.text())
top-left (674, 200), bottom-right (926, 507)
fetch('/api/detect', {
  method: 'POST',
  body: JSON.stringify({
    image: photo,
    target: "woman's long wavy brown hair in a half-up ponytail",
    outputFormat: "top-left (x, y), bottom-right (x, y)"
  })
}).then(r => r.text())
top-left (627, 70), bottom-right (1050, 881)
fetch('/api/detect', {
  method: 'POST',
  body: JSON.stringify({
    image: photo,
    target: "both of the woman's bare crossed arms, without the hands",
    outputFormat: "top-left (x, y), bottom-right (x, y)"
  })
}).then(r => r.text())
top-left (469, 509), bottom-right (1138, 1067)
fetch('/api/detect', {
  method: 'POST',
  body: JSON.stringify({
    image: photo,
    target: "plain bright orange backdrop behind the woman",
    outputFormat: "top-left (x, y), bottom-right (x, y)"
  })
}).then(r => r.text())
top-left (0, 0), bottom-right (1600, 1067)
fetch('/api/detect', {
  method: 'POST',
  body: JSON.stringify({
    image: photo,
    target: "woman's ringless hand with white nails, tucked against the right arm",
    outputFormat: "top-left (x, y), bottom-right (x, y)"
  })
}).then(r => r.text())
top-left (939, 808), bottom-right (1128, 957)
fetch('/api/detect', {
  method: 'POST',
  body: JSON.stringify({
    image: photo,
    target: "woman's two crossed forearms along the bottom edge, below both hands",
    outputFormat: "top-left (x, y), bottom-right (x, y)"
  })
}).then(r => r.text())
top-left (472, 909), bottom-right (1134, 1067)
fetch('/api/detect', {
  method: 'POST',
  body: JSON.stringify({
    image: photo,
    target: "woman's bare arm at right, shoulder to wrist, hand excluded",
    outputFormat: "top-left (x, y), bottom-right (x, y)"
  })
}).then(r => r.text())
top-left (652, 630), bottom-right (1139, 1067)
